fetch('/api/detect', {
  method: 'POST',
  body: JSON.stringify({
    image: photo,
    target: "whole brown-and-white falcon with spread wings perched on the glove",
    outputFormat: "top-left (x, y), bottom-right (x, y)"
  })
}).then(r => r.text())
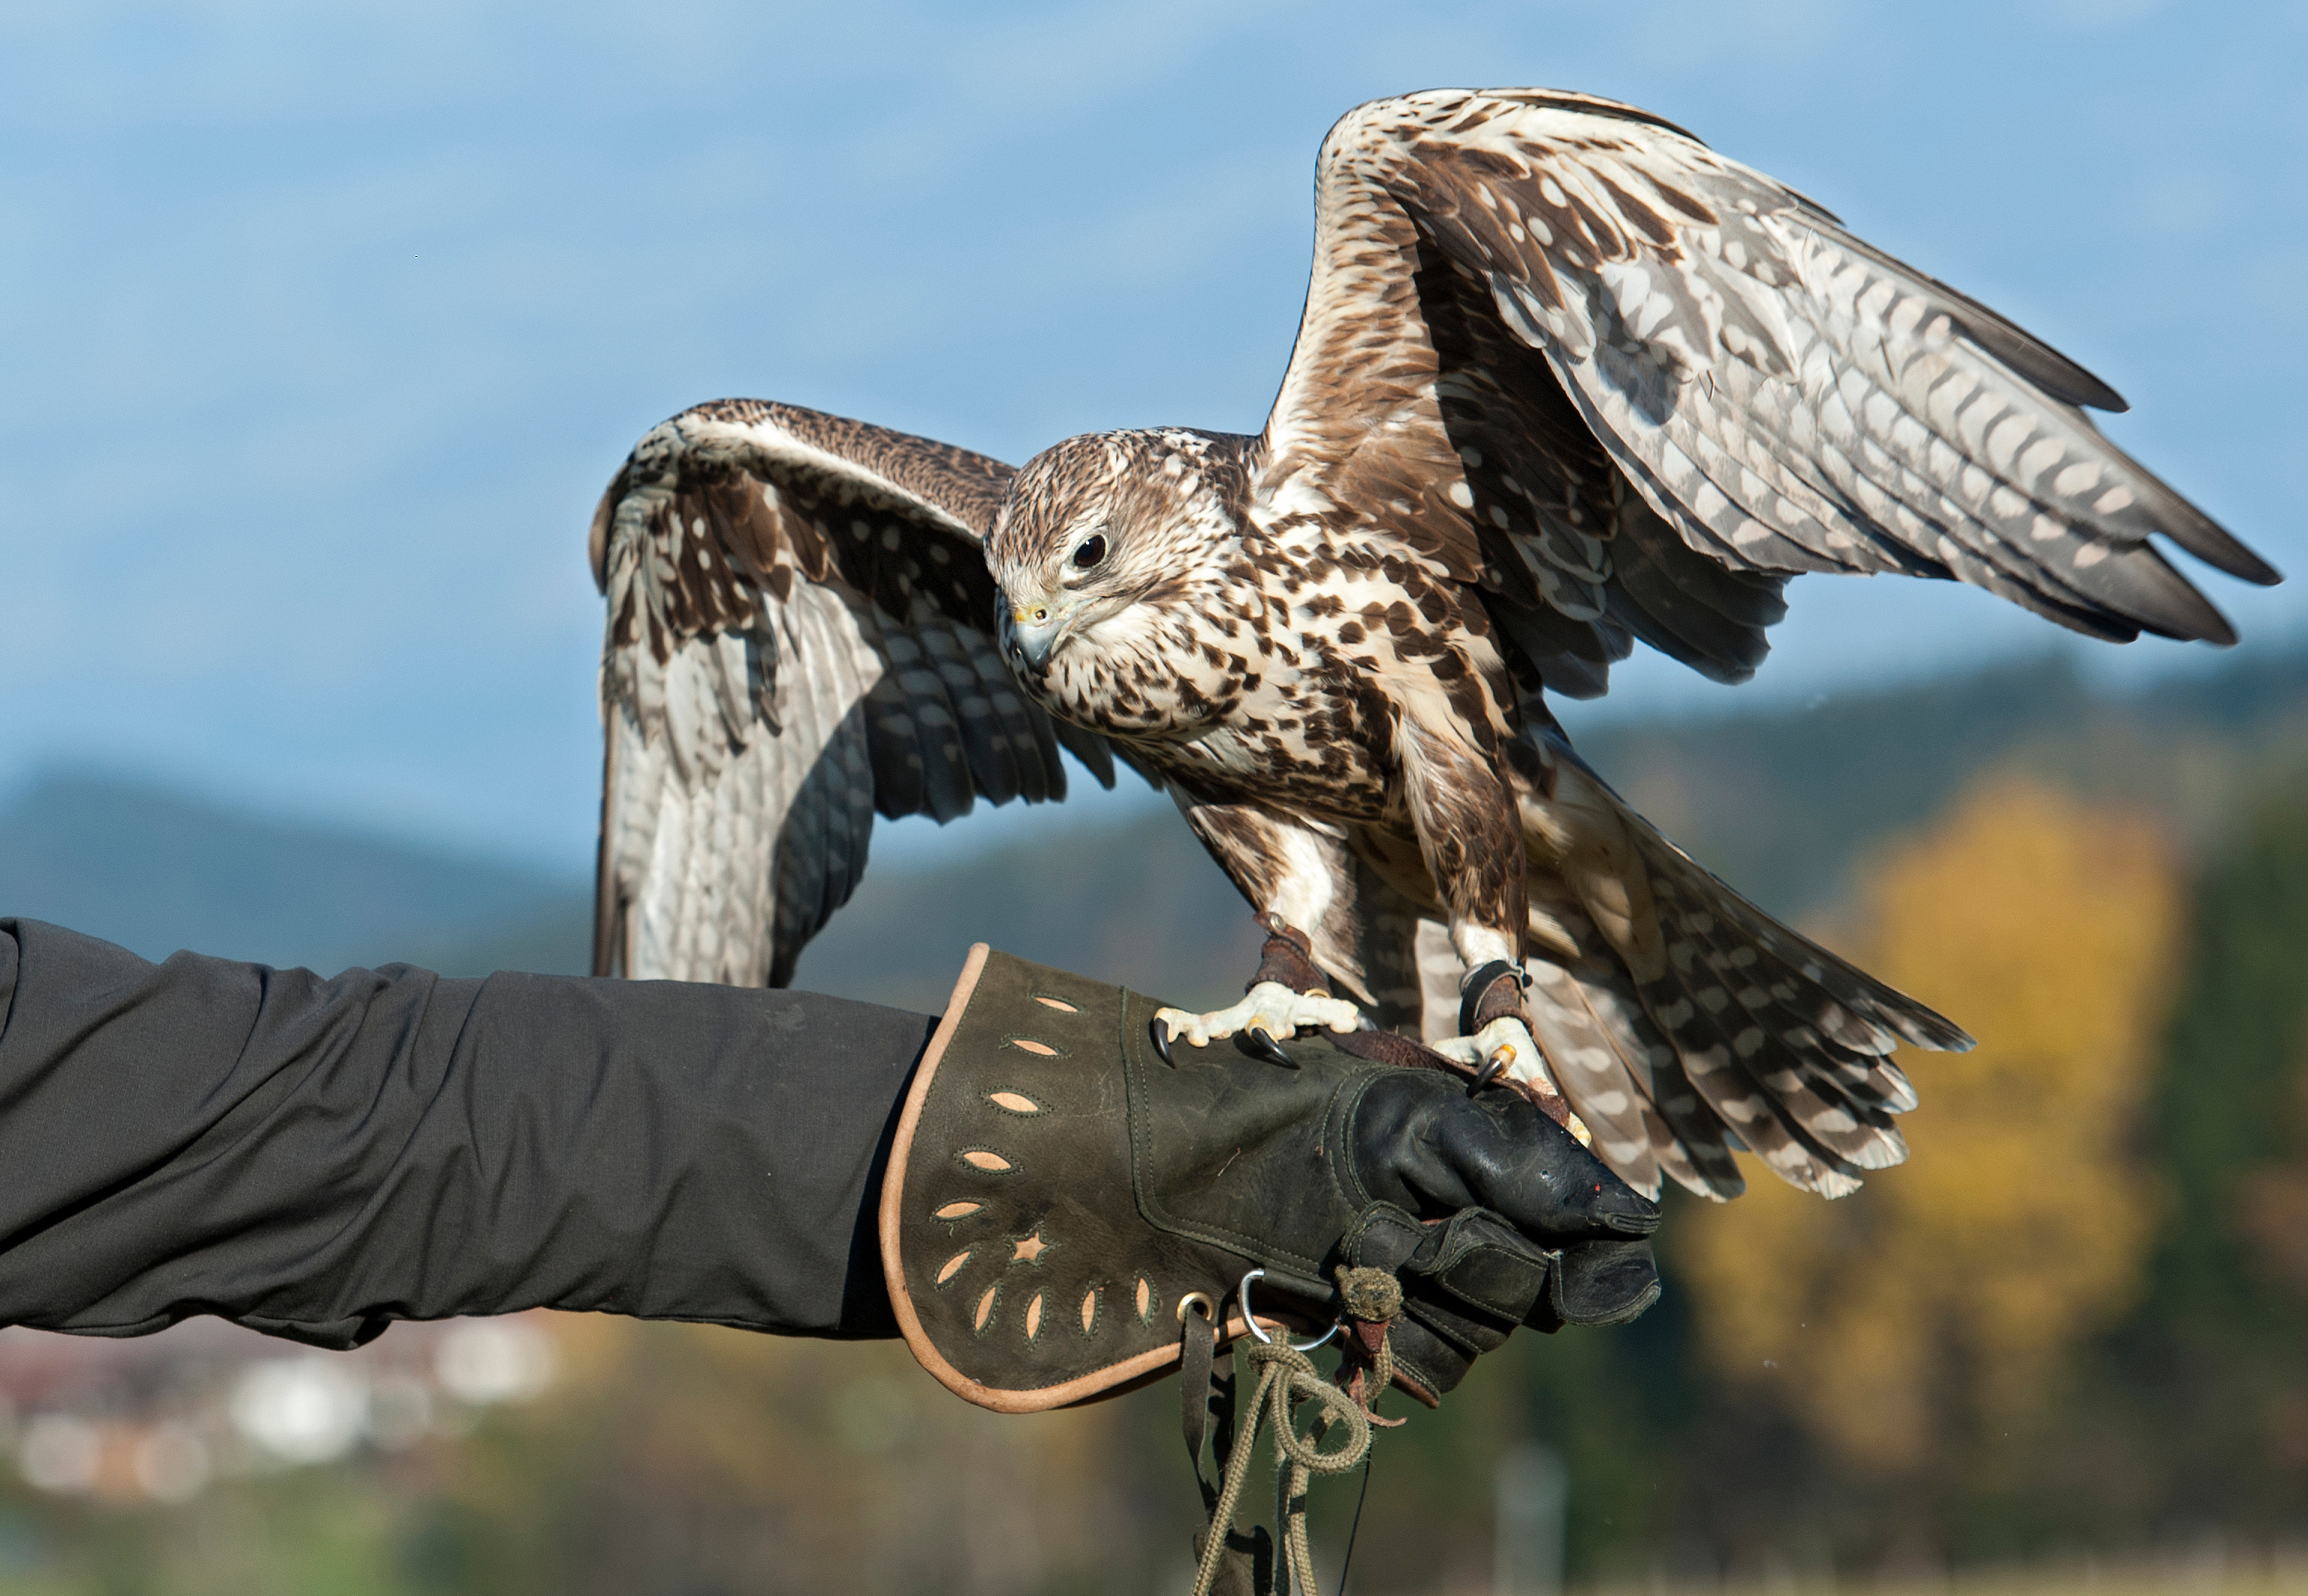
top-left (591, 90), bottom-right (2278, 1197)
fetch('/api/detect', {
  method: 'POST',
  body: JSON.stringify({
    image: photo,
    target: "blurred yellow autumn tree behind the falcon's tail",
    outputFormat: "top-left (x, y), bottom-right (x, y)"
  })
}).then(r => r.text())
top-left (1676, 780), bottom-right (2184, 1474)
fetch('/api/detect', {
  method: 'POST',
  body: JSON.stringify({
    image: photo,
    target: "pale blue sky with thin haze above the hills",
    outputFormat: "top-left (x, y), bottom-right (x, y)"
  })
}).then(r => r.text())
top-left (0, 0), bottom-right (2308, 872)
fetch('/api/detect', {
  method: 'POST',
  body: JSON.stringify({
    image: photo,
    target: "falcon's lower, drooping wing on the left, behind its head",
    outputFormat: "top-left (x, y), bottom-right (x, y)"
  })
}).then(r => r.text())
top-left (591, 399), bottom-right (1113, 985)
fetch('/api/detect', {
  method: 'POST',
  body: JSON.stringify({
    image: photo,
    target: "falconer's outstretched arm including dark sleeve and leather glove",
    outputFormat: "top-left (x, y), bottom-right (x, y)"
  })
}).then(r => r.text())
top-left (0, 920), bottom-right (1658, 1411)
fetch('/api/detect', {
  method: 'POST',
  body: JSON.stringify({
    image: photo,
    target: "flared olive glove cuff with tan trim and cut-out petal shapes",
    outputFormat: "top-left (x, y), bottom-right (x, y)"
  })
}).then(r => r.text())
top-left (880, 943), bottom-right (1265, 1414)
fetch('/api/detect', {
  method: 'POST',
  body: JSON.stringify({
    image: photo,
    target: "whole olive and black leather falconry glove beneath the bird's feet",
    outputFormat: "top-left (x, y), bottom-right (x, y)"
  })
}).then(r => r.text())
top-left (882, 946), bottom-right (1660, 1411)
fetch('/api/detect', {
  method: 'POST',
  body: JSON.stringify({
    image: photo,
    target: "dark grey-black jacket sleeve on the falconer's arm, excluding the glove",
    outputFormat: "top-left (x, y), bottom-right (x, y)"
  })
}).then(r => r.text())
top-left (0, 918), bottom-right (935, 1347)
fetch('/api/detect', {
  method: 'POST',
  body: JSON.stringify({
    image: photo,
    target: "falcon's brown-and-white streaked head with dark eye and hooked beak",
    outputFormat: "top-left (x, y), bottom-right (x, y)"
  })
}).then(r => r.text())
top-left (985, 429), bottom-right (1239, 713)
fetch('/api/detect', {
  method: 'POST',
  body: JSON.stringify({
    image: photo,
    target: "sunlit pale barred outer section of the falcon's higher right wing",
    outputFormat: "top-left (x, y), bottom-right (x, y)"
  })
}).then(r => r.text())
top-left (1327, 90), bottom-right (2276, 644)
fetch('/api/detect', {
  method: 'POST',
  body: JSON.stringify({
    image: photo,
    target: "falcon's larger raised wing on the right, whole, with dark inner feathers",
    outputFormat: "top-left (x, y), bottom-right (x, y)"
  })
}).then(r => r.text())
top-left (1258, 90), bottom-right (2278, 696)
